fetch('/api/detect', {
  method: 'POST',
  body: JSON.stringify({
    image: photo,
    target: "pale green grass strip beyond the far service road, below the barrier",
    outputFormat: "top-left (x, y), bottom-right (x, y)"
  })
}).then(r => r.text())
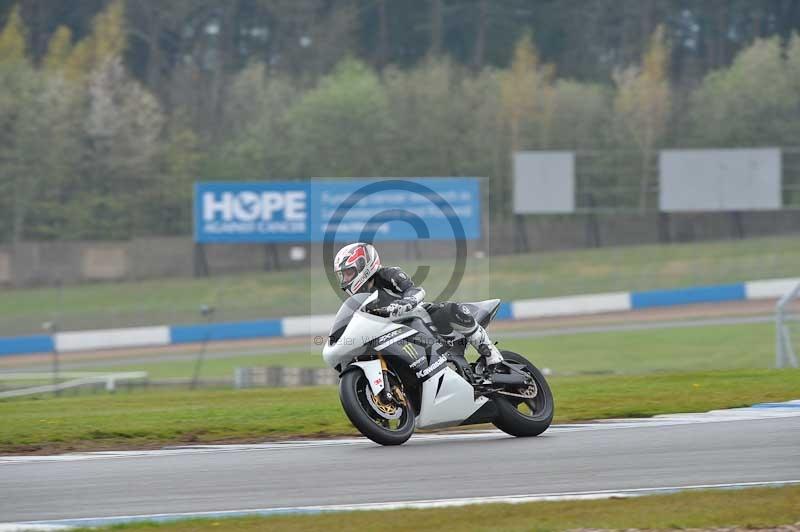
top-left (32, 323), bottom-right (775, 380)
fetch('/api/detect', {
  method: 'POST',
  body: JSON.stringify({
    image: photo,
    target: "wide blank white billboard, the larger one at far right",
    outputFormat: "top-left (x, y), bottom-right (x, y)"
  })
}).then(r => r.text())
top-left (659, 148), bottom-right (783, 212)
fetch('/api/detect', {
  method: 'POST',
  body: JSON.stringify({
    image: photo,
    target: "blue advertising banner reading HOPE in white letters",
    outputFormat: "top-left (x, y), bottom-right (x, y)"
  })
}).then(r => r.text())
top-left (194, 178), bottom-right (481, 243)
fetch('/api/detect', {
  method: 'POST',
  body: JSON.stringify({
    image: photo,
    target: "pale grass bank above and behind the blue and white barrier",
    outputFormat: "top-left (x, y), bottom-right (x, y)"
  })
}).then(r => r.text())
top-left (0, 237), bottom-right (800, 335)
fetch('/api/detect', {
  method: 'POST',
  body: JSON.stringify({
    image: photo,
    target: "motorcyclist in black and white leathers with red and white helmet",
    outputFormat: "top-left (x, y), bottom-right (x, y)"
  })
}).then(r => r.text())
top-left (333, 242), bottom-right (503, 370)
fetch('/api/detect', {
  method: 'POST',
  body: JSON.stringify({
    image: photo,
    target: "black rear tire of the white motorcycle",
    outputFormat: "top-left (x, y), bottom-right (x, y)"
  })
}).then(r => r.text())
top-left (492, 351), bottom-right (555, 437)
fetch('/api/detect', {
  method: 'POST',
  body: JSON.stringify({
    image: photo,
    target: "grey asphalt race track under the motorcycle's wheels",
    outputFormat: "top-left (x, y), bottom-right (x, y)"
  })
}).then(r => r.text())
top-left (0, 401), bottom-right (800, 523)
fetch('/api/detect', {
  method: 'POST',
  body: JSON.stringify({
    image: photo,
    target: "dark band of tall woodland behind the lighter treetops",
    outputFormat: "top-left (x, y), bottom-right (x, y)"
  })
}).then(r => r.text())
top-left (6, 0), bottom-right (800, 84)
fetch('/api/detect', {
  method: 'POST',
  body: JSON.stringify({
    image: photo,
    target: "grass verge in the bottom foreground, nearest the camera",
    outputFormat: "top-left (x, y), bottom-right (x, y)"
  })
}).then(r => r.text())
top-left (83, 486), bottom-right (800, 532)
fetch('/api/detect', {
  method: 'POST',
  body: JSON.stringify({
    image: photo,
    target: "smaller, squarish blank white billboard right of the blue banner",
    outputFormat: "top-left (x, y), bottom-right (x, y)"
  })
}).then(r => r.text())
top-left (514, 151), bottom-right (575, 214)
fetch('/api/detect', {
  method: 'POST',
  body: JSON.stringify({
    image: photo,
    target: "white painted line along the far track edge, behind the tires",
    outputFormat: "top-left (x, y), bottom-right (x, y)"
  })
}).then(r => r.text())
top-left (0, 400), bottom-right (800, 466)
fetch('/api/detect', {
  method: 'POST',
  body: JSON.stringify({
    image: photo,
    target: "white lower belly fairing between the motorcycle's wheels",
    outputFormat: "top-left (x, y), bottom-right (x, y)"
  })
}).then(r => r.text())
top-left (416, 367), bottom-right (488, 429)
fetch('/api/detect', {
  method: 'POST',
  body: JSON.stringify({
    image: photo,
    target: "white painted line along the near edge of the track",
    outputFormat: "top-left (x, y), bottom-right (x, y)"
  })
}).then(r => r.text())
top-left (0, 480), bottom-right (800, 532)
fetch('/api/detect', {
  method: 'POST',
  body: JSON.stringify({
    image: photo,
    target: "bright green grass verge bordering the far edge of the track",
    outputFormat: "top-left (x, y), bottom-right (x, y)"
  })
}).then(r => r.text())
top-left (0, 370), bottom-right (800, 453)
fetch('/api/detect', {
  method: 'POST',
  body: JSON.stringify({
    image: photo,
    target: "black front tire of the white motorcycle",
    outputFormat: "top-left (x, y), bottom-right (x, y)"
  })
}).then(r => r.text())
top-left (339, 370), bottom-right (415, 445)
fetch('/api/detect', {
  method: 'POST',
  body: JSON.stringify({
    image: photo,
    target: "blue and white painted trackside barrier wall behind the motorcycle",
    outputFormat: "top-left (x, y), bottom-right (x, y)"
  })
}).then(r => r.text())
top-left (0, 278), bottom-right (800, 356)
